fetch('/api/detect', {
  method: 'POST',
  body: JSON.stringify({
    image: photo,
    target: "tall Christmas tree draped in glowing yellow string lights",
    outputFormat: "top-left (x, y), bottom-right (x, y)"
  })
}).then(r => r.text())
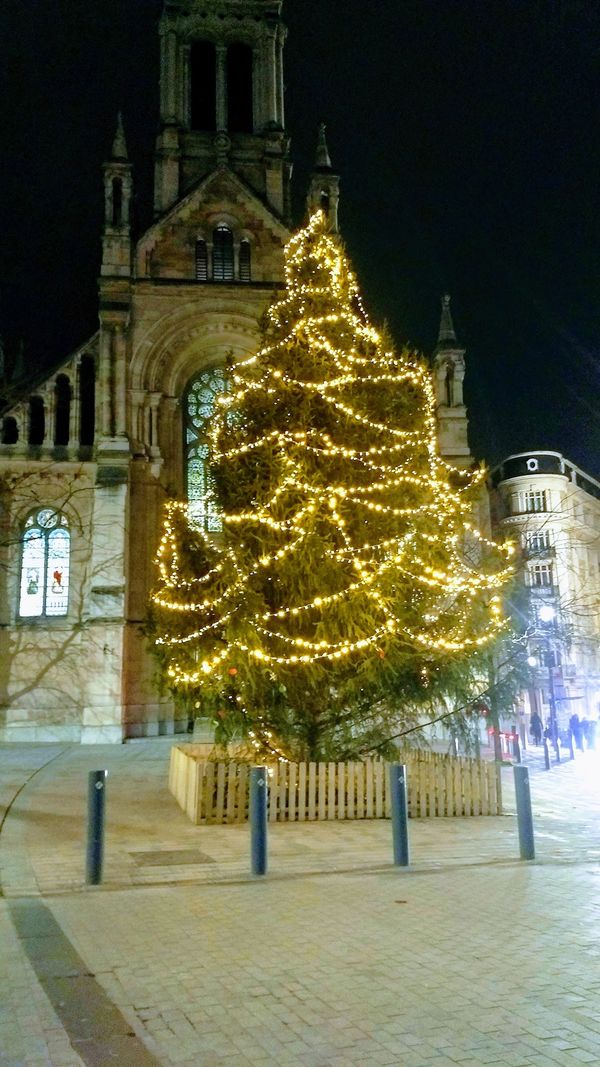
top-left (153, 213), bottom-right (511, 759)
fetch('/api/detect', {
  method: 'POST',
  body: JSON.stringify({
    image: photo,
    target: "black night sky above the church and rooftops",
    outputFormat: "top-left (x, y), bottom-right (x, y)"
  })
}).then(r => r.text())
top-left (0, 0), bottom-right (600, 475)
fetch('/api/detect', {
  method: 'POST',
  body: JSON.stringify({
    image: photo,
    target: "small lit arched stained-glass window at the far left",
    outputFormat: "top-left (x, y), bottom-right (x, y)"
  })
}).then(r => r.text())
top-left (19, 508), bottom-right (70, 619)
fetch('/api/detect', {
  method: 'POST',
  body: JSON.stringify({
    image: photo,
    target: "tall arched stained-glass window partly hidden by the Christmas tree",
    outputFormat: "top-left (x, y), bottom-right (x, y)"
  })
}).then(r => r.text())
top-left (186, 367), bottom-right (226, 534)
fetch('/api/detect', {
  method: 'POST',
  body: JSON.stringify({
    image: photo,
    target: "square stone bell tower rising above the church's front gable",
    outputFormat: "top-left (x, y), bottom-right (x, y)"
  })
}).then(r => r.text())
top-left (155, 0), bottom-right (291, 221)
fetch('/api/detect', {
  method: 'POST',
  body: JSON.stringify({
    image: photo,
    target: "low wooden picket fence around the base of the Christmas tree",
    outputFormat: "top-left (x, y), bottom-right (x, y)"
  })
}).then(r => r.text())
top-left (169, 745), bottom-right (502, 824)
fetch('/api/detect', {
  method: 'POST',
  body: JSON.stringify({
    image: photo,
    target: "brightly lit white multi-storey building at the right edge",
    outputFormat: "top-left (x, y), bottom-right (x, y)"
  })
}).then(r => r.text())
top-left (491, 451), bottom-right (600, 733)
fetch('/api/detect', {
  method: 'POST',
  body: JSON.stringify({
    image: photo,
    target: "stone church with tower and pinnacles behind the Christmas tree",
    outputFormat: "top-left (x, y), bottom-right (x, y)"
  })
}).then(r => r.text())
top-left (0, 0), bottom-right (471, 743)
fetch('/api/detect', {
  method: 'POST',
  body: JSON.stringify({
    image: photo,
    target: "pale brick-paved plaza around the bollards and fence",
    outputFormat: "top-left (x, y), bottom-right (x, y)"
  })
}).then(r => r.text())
top-left (0, 739), bottom-right (600, 1067)
